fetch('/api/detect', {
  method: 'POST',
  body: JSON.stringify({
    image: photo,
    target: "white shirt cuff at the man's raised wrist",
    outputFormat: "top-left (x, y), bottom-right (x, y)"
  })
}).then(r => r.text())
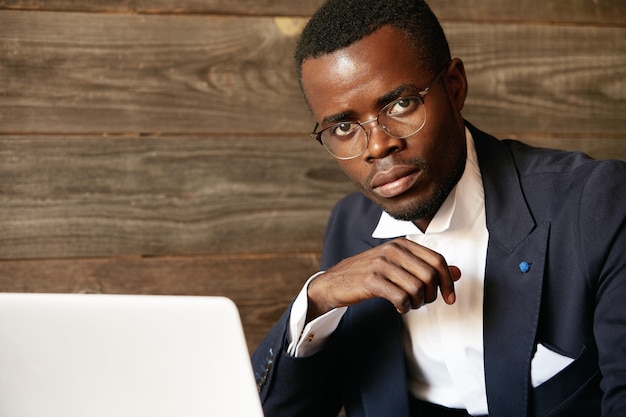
top-left (287, 271), bottom-right (347, 358)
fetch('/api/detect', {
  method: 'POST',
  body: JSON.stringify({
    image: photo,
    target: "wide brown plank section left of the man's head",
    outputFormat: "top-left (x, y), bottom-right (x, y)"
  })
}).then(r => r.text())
top-left (0, 11), bottom-right (313, 133)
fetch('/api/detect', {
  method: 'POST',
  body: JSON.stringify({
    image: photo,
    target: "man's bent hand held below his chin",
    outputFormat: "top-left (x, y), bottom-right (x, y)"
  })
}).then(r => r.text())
top-left (307, 238), bottom-right (461, 322)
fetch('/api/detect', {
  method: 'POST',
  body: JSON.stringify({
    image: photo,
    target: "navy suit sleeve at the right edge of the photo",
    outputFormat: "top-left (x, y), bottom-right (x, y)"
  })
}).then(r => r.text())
top-left (579, 161), bottom-right (626, 417)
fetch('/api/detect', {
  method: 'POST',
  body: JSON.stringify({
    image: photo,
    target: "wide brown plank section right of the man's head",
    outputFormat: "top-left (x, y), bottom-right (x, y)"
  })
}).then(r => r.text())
top-left (446, 23), bottom-right (626, 138)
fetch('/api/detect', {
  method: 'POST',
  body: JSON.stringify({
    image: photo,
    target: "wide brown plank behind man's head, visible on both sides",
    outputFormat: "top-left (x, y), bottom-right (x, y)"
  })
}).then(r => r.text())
top-left (0, 11), bottom-right (626, 137)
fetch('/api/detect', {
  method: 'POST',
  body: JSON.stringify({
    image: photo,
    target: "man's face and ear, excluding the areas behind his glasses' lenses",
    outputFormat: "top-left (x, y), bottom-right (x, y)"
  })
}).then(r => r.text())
top-left (302, 26), bottom-right (467, 230)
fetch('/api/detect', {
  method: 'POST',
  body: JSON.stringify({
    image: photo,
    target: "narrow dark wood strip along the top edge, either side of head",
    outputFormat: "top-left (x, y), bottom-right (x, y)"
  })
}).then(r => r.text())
top-left (0, 0), bottom-right (626, 26)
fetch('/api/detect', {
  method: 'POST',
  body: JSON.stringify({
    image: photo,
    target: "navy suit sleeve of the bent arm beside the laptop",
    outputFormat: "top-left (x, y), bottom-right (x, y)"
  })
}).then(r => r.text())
top-left (252, 194), bottom-right (381, 417)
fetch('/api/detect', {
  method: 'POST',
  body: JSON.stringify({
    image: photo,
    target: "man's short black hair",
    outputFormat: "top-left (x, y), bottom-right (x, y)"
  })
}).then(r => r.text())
top-left (294, 0), bottom-right (450, 84)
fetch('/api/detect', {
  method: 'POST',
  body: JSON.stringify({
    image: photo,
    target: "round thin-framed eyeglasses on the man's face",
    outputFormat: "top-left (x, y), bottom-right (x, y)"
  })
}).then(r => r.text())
top-left (311, 64), bottom-right (448, 160)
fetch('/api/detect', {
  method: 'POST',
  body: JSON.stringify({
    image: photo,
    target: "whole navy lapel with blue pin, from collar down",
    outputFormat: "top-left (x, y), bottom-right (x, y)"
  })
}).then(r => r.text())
top-left (469, 126), bottom-right (550, 417)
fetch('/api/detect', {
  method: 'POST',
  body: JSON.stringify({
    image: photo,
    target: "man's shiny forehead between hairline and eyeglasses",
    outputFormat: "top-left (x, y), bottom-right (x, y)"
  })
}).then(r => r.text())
top-left (302, 26), bottom-right (432, 121)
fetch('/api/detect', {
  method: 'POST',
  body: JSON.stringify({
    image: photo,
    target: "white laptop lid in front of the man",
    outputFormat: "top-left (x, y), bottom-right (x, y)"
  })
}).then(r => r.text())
top-left (0, 293), bottom-right (263, 417)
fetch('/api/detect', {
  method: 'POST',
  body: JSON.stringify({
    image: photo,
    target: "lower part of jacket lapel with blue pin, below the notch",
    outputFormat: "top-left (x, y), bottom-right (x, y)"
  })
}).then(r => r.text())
top-left (483, 223), bottom-right (550, 417)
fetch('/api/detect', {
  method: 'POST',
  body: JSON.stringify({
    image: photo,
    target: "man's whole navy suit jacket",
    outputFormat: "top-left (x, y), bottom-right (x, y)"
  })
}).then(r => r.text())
top-left (253, 124), bottom-right (626, 417)
